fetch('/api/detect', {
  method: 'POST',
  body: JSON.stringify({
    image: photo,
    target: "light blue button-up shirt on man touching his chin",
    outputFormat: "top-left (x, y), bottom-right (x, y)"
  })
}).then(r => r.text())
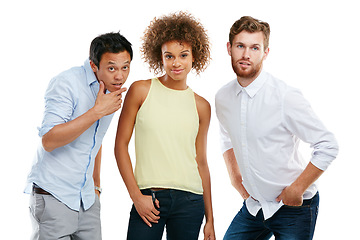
top-left (25, 60), bottom-right (113, 211)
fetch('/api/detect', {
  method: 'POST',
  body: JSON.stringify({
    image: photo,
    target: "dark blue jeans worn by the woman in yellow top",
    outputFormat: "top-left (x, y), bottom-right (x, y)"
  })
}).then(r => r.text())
top-left (127, 189), bottom-right (205, 240)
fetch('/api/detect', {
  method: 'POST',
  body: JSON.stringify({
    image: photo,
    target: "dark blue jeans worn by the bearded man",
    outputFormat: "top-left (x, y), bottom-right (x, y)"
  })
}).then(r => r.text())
top-left (224, 193), bottom-right (319, 240)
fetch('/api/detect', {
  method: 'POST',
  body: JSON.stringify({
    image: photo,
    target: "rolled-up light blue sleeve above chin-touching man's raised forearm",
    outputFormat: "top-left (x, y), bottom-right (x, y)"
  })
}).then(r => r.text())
top-left (38, 77), bottom-right (75, 137)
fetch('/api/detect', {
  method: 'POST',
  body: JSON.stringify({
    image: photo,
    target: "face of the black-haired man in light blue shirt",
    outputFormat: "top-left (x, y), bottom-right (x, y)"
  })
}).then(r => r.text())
top-left (90, 51), bottom-right (131, 92)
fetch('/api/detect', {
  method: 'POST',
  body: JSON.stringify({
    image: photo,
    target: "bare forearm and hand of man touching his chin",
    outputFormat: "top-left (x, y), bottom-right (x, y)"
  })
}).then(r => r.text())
top-left (42, 81), bottom-right (126, 152)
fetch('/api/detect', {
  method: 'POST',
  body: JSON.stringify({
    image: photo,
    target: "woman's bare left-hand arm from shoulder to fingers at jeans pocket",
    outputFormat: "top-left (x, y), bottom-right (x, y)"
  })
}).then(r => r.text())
top-left (115, 80), bottom-right (160, 227)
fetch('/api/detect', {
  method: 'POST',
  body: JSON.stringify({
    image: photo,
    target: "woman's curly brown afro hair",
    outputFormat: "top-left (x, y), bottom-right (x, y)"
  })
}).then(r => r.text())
top-left (140, 12), bottom-right (210, 74)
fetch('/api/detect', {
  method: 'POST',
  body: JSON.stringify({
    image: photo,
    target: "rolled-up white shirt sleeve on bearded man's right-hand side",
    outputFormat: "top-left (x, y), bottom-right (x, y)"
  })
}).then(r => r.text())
top-left (283, 88), bottom-right (339, 170)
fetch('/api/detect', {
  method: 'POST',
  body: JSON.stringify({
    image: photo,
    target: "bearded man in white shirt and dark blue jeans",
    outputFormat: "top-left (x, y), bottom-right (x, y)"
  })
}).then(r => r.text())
top-left (215, 17), bottom-right (338, 240)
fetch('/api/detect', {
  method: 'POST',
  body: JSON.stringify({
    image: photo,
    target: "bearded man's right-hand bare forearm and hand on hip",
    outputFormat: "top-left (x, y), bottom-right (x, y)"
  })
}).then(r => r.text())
top-left (276, 162), bottom-right (324, 206)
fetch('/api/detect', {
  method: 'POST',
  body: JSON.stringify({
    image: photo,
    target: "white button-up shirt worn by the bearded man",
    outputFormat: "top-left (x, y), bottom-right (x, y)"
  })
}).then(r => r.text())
top-left (215, 71), bottom-right (338, 219)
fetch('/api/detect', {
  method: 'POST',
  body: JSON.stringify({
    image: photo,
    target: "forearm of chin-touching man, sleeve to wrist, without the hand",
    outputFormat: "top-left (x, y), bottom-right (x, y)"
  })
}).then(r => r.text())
top-left (42, 109), bottom-right (101, 152)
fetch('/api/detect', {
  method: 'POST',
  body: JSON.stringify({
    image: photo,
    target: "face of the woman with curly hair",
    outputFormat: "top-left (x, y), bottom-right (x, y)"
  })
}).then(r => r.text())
top-left (161, 41), bottom-right (194, 80)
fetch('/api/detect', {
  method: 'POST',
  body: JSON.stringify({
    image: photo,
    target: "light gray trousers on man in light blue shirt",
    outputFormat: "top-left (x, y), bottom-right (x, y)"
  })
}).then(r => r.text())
top-left (30, 190), bottom-right (101, 240)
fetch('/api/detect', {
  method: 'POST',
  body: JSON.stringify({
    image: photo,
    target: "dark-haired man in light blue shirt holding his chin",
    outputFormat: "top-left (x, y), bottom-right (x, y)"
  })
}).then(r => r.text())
top-left (25, 33), bottom-right (133, 240)
